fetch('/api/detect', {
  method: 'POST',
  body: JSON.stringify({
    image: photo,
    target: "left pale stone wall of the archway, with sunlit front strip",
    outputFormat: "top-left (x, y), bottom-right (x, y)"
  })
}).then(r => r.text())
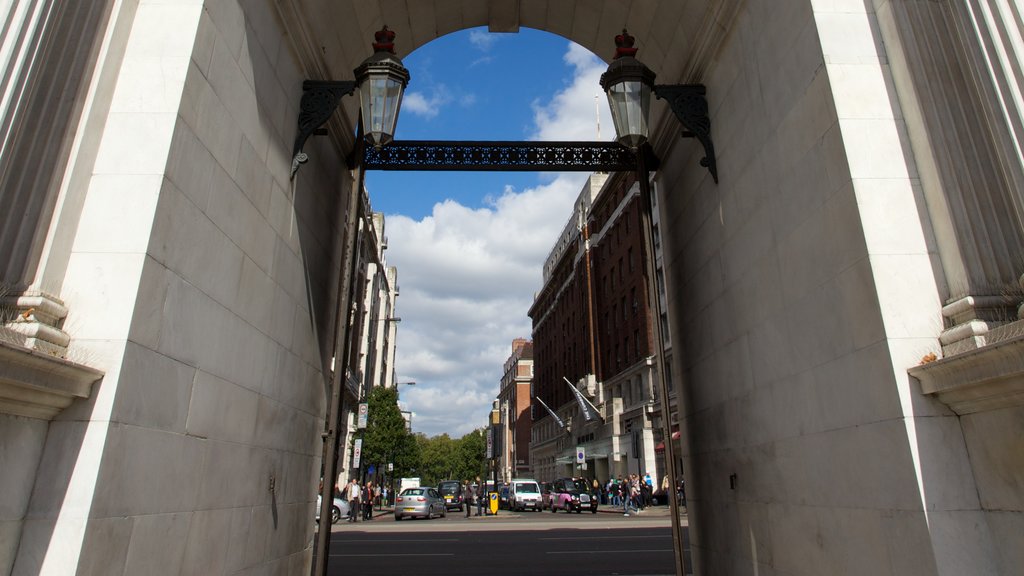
top-left (13, 0), bottom-right (348, 575)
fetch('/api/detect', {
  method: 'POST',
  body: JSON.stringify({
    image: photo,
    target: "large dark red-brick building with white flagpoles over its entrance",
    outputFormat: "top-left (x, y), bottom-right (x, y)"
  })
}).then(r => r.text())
top-left (530, 169), bottom-right (665, 484)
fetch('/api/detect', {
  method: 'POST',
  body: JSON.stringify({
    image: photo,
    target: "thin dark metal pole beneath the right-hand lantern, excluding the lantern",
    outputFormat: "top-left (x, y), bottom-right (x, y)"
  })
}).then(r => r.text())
top-left (637, 145), bottom-right (685, 576)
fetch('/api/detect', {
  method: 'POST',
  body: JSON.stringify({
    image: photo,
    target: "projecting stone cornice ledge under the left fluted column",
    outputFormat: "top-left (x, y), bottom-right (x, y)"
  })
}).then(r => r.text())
top-left (0, 341), bottom-right (103, 420)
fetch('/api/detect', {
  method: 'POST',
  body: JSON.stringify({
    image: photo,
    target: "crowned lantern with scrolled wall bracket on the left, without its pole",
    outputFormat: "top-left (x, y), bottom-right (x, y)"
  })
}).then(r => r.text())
top-left (292, 26), bottom-right (410, 177)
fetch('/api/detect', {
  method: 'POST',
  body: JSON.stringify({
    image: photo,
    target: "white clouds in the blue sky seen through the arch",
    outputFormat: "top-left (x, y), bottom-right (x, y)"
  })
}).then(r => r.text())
top-left (382, 40), bottom-right (611, 438)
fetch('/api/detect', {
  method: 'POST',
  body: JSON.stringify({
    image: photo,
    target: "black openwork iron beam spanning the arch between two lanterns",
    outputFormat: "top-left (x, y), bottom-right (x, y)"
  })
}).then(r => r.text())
top-left (362, 140), bottom-right (656, 172)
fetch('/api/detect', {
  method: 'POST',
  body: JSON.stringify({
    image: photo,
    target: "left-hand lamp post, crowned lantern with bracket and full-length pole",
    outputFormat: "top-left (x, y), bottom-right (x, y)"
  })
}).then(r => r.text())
top-left (311, 26), bottom-right (409, 576)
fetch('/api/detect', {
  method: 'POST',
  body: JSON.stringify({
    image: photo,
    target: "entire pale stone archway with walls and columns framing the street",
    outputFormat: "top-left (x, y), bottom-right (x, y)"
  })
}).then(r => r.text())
top-left (0, 0), bottom-right (1024, 576)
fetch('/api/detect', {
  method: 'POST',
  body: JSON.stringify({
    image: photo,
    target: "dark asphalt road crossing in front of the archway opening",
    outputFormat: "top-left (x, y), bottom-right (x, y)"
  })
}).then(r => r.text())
top-left (328, 511), bottom-right (689, 576)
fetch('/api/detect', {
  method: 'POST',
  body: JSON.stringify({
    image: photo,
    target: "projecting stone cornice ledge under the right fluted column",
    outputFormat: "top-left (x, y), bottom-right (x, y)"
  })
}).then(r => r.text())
top-left (908, 335), bottom-right (1024, 415)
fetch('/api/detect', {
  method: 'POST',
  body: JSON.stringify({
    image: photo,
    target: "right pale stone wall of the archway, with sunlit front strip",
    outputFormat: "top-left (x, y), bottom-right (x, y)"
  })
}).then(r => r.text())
top-left (659, 0), bottom-right (990, 576)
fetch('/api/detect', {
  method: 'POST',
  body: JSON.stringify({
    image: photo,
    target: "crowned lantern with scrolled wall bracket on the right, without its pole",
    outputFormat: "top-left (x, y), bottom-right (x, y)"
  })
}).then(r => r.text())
top-left (601, 30), bottom-right (718, 182)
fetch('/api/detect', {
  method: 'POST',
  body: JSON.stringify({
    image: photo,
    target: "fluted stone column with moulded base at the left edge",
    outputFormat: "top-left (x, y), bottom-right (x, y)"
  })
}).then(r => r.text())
top-left (0, 0), bottom-right (110, 356)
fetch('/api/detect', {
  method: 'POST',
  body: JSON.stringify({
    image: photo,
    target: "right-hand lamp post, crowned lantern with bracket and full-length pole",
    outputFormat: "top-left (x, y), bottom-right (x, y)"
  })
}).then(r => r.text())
top-left (601, 30), bottom-right (718, 576)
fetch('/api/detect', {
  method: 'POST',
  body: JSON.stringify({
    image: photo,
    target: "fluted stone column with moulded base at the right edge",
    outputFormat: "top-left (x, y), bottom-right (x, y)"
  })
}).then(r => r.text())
top-left (891, 0), bottom-right (1024, 356)
